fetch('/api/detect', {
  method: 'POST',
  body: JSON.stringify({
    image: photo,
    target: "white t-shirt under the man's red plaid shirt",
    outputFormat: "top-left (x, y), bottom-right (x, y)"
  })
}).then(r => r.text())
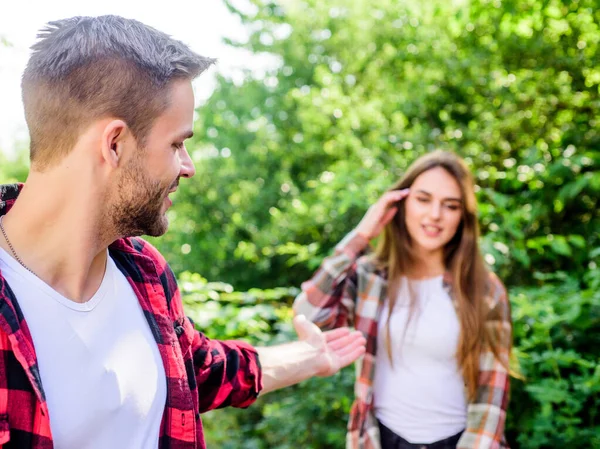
top-left (0, 249), bottom-right (166, 449)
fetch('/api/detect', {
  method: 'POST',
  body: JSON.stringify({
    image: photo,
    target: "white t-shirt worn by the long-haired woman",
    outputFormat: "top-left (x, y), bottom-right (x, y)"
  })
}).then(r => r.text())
top-left (374, 276), bottom-right (467, 443)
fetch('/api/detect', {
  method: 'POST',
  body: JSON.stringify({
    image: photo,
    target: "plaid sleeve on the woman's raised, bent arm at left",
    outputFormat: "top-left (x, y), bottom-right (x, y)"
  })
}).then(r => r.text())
top-left (293, 232), bottom-right (369, 329)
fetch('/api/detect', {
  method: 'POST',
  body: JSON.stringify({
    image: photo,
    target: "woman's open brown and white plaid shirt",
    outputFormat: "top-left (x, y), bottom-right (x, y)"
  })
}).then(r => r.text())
top-left (294, 233), bottom-right (512, 449)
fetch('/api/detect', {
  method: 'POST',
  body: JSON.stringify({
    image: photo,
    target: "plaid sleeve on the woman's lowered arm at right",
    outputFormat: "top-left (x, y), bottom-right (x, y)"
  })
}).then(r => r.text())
top-left (456, 274), bottom-right (512, 449)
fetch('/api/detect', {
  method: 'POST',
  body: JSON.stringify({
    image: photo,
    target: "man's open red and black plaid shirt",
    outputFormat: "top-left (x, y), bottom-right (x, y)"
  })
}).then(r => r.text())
top-left (0, 184), bottom-right (262, 449)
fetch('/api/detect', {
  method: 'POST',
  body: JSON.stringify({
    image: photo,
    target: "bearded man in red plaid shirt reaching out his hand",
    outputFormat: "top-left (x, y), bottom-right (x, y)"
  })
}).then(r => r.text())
top-left (0, 16), bottom-right (365, 449)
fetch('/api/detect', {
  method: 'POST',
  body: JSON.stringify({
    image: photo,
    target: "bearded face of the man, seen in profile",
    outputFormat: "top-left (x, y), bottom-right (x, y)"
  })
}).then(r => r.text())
top-left (111, 81), bottom-right (195, 237)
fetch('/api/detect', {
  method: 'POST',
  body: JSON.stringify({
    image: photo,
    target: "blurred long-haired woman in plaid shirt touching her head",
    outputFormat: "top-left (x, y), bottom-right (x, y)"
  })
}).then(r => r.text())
top-left (294, 151), bottom-right (512, 449)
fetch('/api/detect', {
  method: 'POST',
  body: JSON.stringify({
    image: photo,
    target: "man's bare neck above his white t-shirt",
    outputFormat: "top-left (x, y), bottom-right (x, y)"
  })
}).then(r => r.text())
top-left (0, 174), bottom-right (117, 302)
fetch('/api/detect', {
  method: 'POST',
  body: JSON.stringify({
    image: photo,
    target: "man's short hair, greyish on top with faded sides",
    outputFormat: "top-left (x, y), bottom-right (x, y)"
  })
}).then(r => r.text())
top-left (21, 16), bottom-right (214, 169)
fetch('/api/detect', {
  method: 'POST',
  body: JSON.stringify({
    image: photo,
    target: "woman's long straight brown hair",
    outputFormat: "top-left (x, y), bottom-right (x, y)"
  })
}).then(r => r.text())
top-left (374, 151), bottom-right (508, 399)
